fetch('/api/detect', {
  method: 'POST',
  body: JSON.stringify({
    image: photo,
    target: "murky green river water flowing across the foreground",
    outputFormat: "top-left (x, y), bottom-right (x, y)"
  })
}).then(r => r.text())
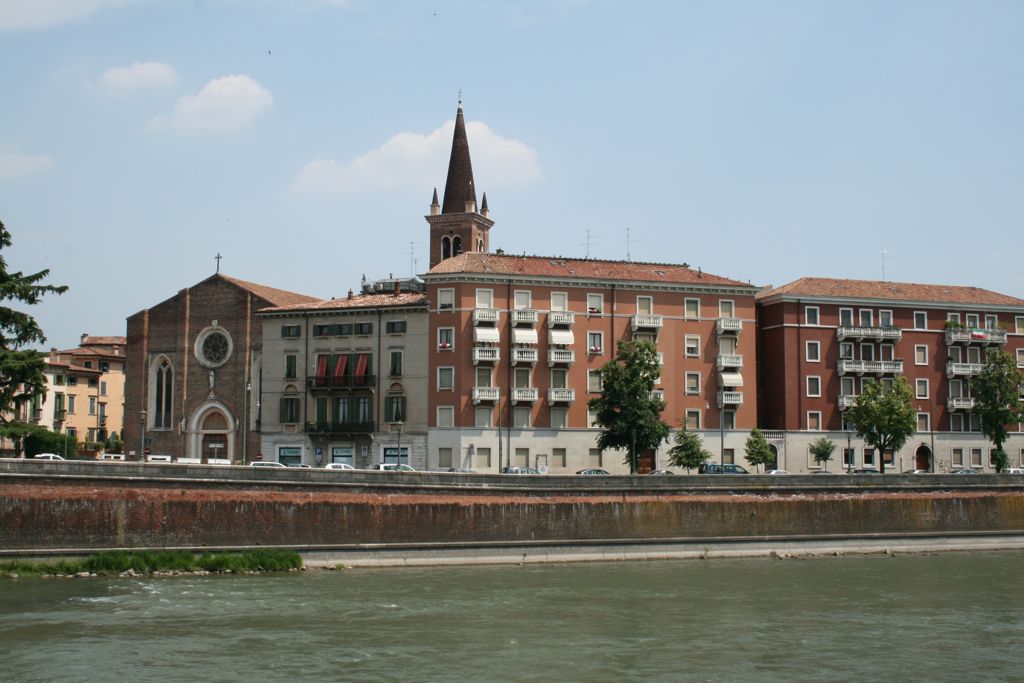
top-left (0, 552), bottom-right (1024, 682)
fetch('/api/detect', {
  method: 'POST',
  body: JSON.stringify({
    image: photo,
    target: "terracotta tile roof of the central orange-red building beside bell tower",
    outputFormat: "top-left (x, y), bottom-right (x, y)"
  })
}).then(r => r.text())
top-left (429, 252), bottom-right (757, 289)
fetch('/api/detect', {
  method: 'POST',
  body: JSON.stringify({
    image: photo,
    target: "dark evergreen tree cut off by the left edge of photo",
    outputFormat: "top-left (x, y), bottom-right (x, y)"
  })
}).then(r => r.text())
top-left (0, 221), bottom-right (68, 438)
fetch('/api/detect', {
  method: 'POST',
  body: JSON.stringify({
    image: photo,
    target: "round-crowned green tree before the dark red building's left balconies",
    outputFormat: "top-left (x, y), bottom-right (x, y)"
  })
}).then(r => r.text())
top-left (846, 377), bottom-right (918, 474)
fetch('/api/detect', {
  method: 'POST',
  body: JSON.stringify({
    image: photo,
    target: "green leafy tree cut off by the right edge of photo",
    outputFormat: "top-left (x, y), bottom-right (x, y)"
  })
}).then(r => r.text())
top-left (971, 349), bottom-right (1024, 472)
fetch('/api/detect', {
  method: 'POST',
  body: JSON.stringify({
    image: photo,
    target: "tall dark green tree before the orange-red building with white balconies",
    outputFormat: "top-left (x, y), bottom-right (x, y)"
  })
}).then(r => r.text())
top-left (587, 341), bottom-right (670, 473)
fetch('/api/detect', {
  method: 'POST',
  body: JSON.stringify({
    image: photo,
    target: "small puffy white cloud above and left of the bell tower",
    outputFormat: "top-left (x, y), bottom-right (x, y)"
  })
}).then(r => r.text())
top-left (148, 74), bottom-right (273, 130)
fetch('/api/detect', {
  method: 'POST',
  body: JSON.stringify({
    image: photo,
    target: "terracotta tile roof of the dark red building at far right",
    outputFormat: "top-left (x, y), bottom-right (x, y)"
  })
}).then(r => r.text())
top-left (758, 278), bottom-right (1024, 306)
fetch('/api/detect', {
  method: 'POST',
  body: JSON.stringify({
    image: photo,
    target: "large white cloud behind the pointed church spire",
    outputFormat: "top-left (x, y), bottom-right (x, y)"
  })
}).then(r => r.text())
top-left (292, 121), bottom-right (542, 196)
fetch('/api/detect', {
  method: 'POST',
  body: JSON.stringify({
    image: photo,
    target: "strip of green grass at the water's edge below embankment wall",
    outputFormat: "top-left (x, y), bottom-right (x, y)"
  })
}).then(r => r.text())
top-left (0, 548), bottom-right (302, 577)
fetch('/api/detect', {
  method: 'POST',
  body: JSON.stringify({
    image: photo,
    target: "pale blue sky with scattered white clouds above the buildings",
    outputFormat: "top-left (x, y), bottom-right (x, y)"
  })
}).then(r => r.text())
top-left (0, 0), bottom-right (1024, 348)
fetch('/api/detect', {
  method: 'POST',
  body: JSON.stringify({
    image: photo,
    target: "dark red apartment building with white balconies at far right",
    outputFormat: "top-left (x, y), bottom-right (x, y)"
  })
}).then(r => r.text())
top-left (758, 278), bottom-right (1024, 471)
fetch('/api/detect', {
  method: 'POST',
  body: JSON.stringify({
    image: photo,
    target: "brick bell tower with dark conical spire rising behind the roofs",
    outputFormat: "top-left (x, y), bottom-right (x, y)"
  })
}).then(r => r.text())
top-left (426, 101), bottom-right (495, 268)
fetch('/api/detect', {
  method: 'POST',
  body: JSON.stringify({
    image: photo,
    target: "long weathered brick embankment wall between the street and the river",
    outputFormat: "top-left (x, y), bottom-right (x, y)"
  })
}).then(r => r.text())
top-left (0, 465), bottom-right (1024, 551)
